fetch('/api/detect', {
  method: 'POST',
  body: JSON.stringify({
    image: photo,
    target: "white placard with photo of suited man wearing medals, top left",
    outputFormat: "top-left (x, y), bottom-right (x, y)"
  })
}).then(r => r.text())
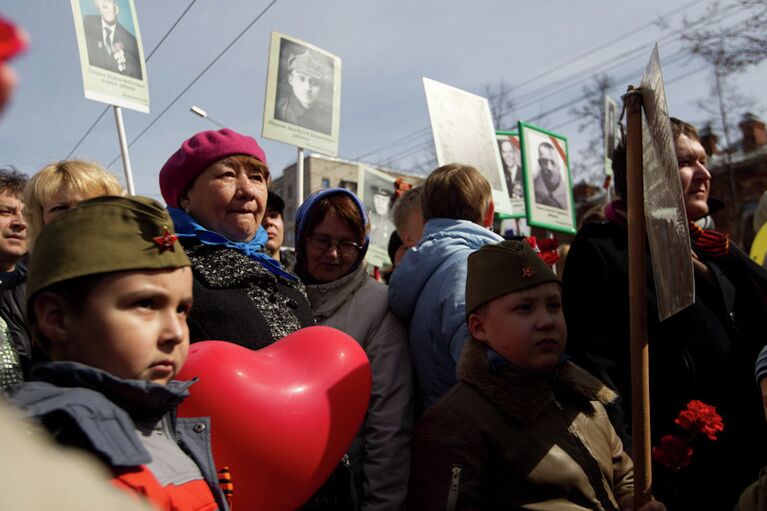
top-left (71, 0), bottom-right (149, 113)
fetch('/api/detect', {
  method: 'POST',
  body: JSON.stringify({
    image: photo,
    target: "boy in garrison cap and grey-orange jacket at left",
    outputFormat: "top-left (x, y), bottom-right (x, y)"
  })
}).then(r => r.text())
top-left (9, 197), bottom-right (228, 510)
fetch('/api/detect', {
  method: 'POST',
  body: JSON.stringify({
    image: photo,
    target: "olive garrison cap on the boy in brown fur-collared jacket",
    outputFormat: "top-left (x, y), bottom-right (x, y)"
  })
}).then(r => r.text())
top-left (466, 240), bottom-right (559, 319)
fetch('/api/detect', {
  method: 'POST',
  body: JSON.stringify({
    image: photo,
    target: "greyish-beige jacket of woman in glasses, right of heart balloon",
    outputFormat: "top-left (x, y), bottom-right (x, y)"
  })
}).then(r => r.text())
top-left (306, 264), bottom-right (413, 511)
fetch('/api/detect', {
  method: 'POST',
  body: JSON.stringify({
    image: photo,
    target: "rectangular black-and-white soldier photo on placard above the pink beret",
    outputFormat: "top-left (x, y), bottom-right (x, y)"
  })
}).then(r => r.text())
top-left (274, 39), bottom-right (333, 135)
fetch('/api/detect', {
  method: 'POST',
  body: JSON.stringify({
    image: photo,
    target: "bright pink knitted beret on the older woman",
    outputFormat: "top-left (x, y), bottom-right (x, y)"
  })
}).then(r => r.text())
top-left (160, 128), bottom-right (266, 208)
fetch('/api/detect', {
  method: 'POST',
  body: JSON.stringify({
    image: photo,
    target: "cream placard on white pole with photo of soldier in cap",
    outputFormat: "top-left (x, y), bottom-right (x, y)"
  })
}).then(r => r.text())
top-left (261, 32), bottom-right (341, 156)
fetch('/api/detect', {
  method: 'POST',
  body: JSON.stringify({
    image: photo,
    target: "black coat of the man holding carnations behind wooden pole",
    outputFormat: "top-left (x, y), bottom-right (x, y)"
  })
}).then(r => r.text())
top-left (562, 222), bottom-right (767, 509)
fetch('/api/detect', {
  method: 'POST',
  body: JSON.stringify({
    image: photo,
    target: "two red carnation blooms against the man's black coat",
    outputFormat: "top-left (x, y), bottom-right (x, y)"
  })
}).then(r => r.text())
top-left (652, 400), bottom-right (724, 470)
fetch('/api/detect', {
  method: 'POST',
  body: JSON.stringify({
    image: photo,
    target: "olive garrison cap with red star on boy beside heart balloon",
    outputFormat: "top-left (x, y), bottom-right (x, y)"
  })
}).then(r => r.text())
top-left (27, 197), bottom-right (190, 309)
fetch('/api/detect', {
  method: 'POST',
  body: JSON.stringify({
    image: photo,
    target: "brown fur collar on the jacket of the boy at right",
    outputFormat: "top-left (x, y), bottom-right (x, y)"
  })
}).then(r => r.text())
top-left (458, 340), bottom-right (618, 424)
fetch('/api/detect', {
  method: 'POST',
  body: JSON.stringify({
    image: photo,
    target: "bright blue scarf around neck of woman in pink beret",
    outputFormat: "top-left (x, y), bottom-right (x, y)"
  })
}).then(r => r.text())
top-left (168, 207), bottom-right (298, 280)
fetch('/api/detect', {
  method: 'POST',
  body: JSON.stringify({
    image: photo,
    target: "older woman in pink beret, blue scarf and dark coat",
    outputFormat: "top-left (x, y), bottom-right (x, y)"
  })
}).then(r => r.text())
top-left (160, 129), bottom-right (314, 349)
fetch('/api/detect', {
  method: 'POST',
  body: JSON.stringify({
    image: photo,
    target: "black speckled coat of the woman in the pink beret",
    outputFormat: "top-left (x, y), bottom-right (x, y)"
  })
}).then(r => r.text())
top-left (184, 242), bottom-right (314, 349)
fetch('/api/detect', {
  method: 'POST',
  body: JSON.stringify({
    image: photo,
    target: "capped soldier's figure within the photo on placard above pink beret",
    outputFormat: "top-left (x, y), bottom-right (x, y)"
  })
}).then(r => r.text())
top-left (274, 49), bottom-right (332, 135)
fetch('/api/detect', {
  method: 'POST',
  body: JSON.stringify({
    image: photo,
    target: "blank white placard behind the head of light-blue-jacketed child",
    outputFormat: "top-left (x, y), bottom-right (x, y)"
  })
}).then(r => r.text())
top-left (423, 78), bottom-right (512, 214)
